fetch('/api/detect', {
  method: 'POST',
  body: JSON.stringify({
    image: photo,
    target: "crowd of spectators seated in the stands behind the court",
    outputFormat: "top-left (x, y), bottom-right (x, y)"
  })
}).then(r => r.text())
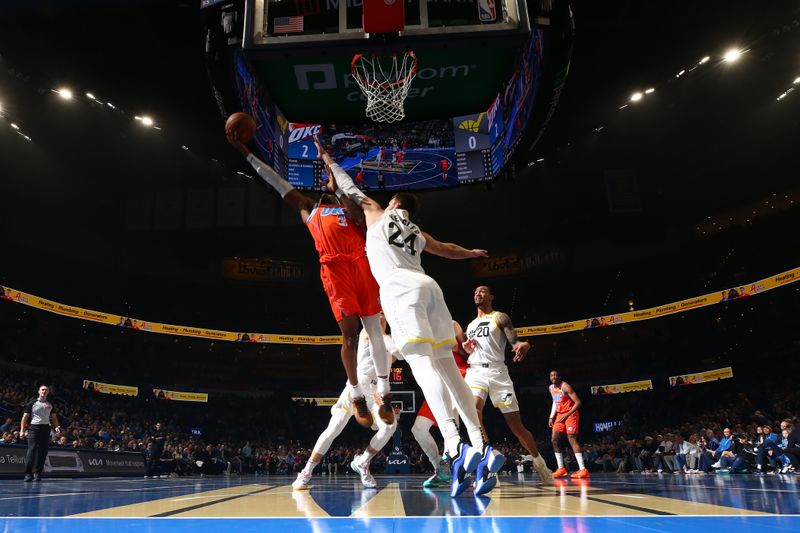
top-left (0, 358), bottom-right (800, 476)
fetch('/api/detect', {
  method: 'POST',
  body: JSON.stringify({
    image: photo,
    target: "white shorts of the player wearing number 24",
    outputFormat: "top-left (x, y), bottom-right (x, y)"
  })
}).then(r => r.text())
top-left (381, 269), bottom-right (456, 361)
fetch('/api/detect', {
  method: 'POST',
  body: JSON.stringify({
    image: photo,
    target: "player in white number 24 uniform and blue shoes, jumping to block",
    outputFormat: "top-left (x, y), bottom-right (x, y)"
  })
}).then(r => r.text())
top-left (317, 136), bottom-right (505, 496)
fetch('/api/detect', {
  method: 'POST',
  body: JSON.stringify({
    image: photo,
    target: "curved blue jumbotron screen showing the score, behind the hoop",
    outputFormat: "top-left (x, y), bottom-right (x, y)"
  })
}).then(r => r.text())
top-left (236, 29), bottom-right (543, 191)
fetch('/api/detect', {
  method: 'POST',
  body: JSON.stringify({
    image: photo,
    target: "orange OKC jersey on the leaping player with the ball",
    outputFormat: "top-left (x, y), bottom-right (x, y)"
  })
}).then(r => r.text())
top-left (306, 204), bottom-right (366, 264)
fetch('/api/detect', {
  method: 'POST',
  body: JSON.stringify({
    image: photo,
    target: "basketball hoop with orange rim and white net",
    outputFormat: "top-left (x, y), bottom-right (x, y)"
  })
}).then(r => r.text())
top-left (351, 52), bottom-right (417, 122)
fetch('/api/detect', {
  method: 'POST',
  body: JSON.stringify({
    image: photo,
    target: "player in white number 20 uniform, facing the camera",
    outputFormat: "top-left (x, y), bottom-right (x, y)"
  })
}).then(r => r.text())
top-left (463, 285), bottom-right (553, 484)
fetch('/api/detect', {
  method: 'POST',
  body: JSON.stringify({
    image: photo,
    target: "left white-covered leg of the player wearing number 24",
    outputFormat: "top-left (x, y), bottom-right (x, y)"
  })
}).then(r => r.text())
top-left (406, 356), bottom-right (460, 457)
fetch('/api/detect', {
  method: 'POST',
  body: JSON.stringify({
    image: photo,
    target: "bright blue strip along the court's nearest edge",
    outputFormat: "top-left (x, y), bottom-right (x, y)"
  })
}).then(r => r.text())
top-left (0, 516), bottom-right (800, 533)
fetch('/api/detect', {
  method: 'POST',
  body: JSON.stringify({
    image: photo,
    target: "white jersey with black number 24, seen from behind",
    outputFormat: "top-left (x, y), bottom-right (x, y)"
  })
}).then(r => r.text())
top-left (367, 209), bottom-right (426, 287)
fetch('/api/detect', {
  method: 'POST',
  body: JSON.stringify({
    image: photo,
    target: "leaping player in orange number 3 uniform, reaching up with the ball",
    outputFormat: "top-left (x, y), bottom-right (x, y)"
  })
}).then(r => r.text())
top-left (227, 130), bottom-right (394, 427)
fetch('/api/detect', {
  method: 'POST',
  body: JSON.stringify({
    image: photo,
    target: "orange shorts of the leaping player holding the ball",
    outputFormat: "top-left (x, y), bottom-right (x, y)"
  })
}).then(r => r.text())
top-left (319, 257), bottom-right (381, 322)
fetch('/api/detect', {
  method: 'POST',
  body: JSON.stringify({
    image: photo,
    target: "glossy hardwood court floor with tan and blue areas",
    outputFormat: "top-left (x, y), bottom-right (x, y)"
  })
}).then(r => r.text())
top-left (0, 474), bottom-right (800, 533)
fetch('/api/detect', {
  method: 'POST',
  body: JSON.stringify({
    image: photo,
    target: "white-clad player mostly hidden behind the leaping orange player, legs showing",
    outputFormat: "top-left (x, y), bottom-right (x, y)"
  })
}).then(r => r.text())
top-left (292, 317), bottom-right (399, 490)
